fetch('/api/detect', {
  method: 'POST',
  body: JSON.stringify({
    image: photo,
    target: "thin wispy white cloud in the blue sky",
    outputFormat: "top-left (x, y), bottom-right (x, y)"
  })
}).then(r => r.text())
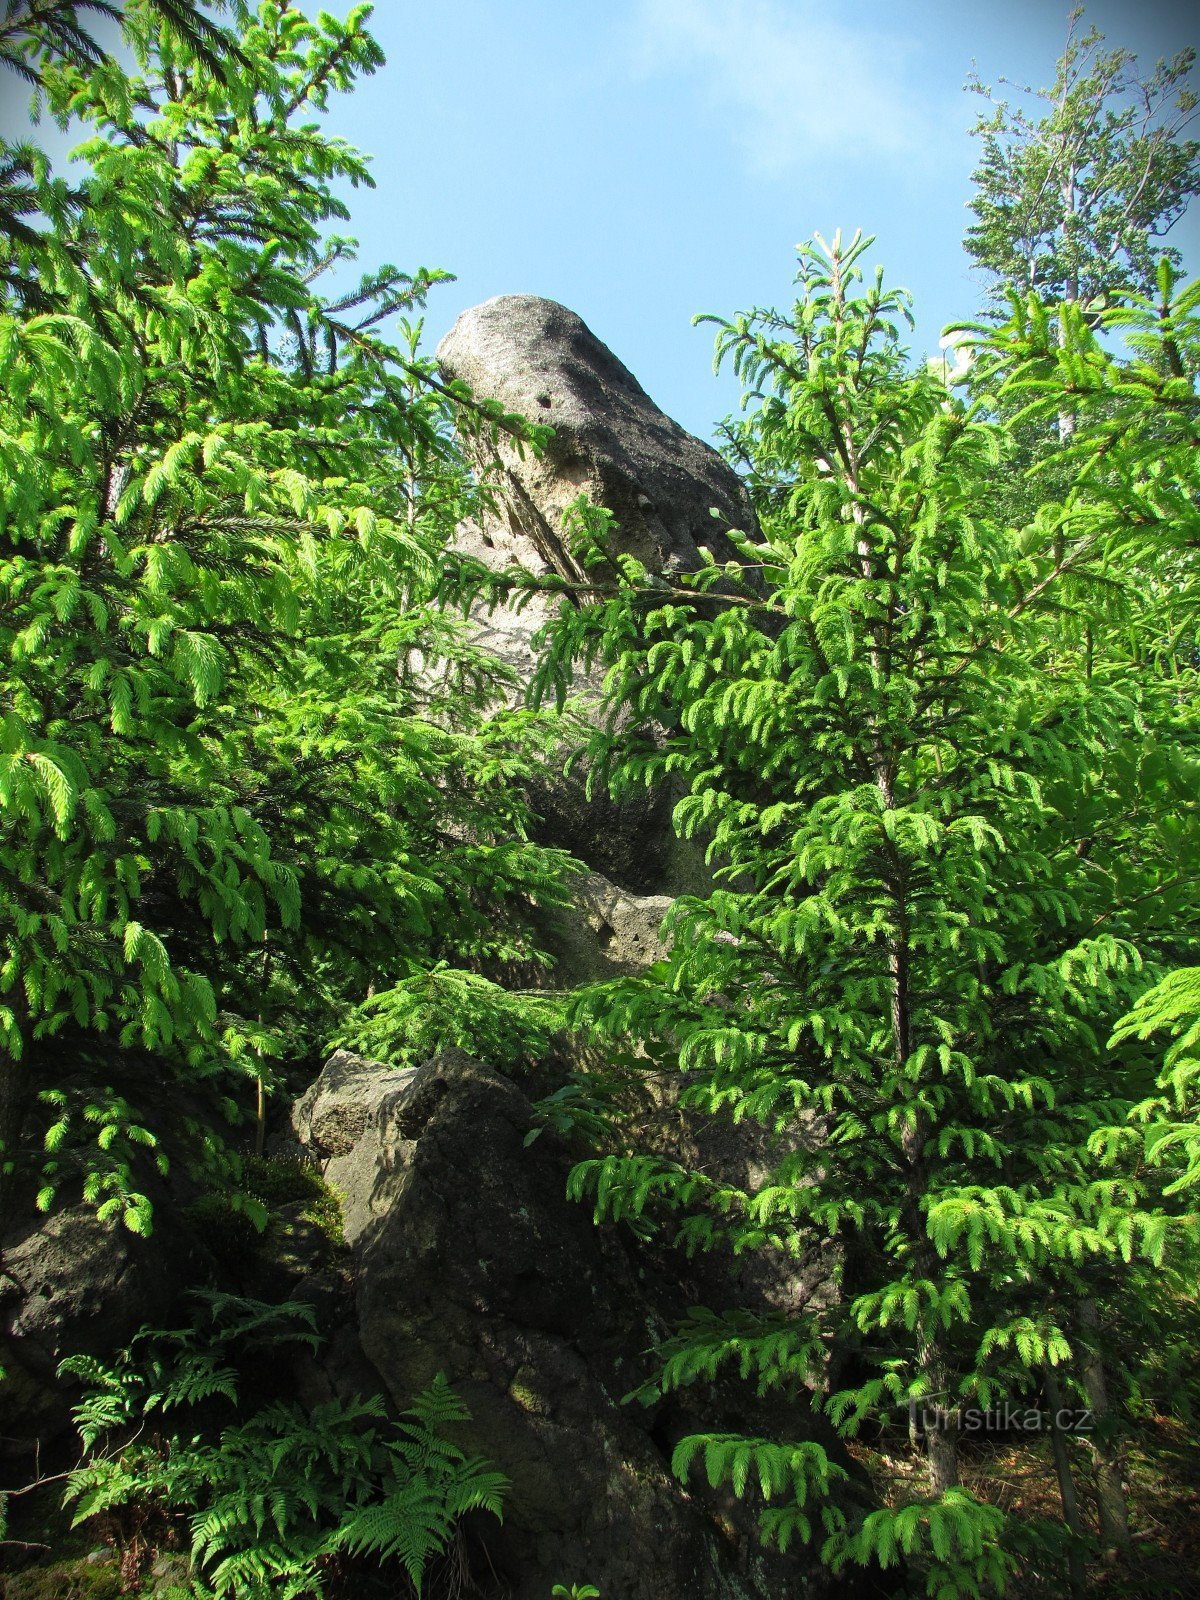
top-left (634, 0), bottom-right (957, 176)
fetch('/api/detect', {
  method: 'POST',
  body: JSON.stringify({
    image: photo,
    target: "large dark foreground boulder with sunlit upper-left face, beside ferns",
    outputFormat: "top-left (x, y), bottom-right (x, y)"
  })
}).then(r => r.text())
top-left (296, 1050), bottom-right (870, 1600)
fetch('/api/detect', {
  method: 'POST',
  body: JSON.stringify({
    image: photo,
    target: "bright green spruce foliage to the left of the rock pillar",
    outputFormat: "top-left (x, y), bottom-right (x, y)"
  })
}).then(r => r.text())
top-left (0, 0), bottom-right (572, 1230)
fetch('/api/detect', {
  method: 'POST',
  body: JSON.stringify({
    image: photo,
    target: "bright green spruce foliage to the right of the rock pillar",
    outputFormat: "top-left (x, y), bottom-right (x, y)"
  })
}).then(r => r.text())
top-left (544, 237), bottom-right (1200, 1595)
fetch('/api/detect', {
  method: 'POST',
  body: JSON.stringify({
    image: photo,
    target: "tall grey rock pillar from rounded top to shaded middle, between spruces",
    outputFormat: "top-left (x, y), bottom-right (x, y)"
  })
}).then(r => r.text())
top-left (437, 294), bottom-right (757, 896)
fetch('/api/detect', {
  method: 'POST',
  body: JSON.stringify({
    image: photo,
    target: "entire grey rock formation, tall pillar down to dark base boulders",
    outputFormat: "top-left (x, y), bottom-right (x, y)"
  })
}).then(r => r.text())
top-left (0, 296), bottom-right (877, 1600)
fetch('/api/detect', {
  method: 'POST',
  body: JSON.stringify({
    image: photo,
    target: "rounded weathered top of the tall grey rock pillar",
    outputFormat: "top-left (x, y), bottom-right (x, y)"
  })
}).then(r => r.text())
top-left (437, 294), bottom-right (754, 576)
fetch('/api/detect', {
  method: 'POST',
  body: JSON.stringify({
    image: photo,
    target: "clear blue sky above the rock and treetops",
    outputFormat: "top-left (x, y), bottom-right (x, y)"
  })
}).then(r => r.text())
top-left (2, 0), bottom-right (1200, 434)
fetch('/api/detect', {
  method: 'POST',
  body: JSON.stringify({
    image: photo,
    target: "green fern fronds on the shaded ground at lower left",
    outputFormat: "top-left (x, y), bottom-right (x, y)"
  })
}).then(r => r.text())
top-left (62, 1294), bottom-right (509, 1600)
